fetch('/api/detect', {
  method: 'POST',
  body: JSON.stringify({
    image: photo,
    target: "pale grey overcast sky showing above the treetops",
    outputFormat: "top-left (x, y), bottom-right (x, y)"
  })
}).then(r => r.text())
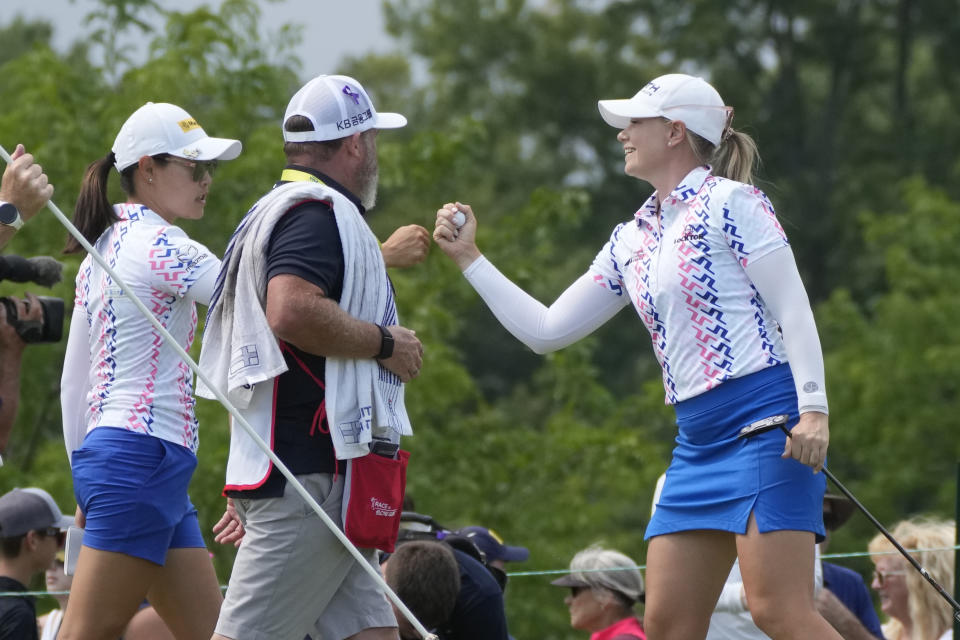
top-left (0, 0), bottom-right (394, 79)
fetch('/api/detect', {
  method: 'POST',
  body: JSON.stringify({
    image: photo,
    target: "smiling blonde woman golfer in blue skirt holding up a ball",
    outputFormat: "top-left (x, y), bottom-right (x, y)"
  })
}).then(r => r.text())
top-left (434, 74), bottom-right (840, 640)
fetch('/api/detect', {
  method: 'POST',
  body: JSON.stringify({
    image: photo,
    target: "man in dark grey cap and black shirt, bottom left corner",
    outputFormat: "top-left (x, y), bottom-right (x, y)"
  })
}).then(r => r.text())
top-left (0, 487), bottom-right (73, 640)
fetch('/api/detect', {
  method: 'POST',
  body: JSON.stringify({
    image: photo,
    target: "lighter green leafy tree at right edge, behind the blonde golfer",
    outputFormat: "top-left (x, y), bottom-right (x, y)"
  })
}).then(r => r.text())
top-left (818, 178), bottom-right (960, 556)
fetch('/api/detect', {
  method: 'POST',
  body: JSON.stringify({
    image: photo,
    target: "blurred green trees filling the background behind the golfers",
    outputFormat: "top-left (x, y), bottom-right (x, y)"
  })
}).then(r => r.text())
top-left (0, 0), bottom-right (960, 640)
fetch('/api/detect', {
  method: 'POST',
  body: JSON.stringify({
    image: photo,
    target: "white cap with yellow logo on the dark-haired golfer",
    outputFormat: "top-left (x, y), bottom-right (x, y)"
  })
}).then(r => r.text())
top-left (113, 102), bottom-right (242, 171)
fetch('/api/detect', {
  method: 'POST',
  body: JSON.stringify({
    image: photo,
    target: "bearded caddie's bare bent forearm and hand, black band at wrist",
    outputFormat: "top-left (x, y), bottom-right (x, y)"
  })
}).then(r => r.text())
top-left (267, 274), bottom-right (423, 382)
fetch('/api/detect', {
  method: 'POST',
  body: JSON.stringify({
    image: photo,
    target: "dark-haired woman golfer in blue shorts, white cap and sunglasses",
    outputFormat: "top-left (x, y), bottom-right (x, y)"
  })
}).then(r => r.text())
top-left (59, 103), bottom-right (240, 640)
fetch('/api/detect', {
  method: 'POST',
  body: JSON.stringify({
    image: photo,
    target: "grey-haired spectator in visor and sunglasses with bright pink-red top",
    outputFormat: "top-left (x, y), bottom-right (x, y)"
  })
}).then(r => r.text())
top-left (550, 545), bottom-right (647, 640)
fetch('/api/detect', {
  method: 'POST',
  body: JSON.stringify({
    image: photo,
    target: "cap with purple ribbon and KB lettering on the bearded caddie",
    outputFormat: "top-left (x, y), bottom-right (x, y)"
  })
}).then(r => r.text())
top-left (281, 75), bottom-right (407, 142)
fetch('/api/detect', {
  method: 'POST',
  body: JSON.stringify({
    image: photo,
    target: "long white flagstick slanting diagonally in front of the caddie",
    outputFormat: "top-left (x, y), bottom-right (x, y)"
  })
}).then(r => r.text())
top-left (0, 145), bottom-right (436, 640)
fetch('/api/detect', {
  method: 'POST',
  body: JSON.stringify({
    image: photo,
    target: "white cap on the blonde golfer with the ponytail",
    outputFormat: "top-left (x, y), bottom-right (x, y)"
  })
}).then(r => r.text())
top-left (597, 73), bottom-right (733, 146)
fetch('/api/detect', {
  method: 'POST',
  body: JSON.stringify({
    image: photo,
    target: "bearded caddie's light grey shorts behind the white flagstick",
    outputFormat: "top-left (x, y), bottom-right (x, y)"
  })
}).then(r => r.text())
top-left (217, 473), bottom-right (397, 640)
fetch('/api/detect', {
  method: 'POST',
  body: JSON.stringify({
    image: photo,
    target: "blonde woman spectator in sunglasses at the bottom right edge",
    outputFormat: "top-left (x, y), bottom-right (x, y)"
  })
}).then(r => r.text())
top-left (867, 518), bottom-right (955, 640)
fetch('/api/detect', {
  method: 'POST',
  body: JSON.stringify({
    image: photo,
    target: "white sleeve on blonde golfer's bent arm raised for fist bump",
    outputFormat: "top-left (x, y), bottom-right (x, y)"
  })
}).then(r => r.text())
top-left (463, 256), bottom-right (630, 353)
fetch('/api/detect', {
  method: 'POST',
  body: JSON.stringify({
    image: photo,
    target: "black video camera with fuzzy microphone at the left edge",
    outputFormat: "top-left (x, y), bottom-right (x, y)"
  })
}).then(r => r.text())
top-left (0, 256), bottom-right (64, 343)
